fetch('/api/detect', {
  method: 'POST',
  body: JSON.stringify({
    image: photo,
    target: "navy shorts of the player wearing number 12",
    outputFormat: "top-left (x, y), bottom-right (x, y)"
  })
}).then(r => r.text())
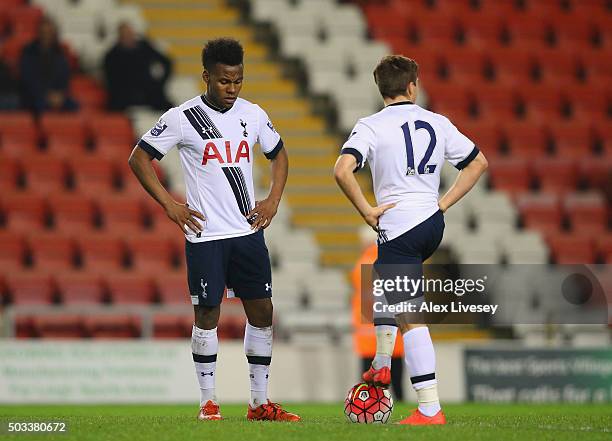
top-left (374, 210), bottom-right (444, 312)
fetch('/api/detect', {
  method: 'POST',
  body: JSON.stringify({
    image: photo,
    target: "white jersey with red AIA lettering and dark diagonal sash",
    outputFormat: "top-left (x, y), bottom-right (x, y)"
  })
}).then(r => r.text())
top-left (138, 96), bottom-right (283, 242)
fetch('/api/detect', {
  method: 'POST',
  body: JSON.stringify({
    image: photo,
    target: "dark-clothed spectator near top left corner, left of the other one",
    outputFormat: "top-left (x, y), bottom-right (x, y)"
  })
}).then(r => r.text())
top-left (19, 18), bottom-right (78, 113)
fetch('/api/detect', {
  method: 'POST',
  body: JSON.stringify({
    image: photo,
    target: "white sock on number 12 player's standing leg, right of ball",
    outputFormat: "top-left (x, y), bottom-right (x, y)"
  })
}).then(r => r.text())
top-left (403, 326), bottom-right (441, 416)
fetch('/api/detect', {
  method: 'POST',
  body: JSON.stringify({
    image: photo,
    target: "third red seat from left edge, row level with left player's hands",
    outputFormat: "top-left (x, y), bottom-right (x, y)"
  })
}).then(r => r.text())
top-left (97, 195), bottom-right (145, 235)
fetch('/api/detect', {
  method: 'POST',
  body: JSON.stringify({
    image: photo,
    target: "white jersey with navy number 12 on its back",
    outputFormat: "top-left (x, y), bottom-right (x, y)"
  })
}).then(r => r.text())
top-left (342, 102), bottom-right (479, 242)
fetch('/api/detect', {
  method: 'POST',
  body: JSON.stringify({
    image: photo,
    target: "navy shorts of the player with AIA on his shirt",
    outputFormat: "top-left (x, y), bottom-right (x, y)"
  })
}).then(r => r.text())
top-left (185, 230), bottom-right (272, 306)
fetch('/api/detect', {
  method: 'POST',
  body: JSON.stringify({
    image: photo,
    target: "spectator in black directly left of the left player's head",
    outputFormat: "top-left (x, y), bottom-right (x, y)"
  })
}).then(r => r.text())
top-left (104, 22), bottom-right (173, 110)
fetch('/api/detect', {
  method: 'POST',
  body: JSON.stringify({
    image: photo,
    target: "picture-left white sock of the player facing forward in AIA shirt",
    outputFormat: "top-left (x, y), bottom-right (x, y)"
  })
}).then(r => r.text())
top-left (191, 325), bottom-right (219, 406)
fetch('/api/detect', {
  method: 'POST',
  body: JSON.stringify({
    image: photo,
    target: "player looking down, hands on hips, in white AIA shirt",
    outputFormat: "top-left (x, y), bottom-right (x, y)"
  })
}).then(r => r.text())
top-left (129, 38), bottom-right (300, 421)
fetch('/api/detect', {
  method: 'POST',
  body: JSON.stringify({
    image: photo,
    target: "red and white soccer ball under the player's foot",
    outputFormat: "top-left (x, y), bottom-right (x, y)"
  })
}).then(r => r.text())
top-left (344, 383), bottom-right (393, 424)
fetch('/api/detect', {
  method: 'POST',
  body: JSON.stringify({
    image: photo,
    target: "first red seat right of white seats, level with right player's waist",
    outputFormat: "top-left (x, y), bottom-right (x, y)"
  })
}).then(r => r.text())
top-left (517, 193), bottom-right (563, 233)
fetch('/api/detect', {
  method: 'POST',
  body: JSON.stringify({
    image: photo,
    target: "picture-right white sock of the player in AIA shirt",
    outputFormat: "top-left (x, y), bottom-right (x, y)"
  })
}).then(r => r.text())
top-left (244, 323), bottom-right (272, 408)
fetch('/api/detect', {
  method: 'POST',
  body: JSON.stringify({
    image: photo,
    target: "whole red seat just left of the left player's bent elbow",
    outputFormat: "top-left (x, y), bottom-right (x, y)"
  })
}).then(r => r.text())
top-left (69, 156), bottom-right (116, 196)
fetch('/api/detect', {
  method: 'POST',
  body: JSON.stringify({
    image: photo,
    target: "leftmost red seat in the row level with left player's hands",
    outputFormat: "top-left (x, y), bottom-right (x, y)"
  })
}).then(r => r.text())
top-left (0, 193), bottom-right (47, 232)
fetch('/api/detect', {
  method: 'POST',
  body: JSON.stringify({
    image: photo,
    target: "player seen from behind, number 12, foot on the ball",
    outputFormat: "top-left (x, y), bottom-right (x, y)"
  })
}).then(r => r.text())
top-left (334, 55), bottom-right (487, 425)
